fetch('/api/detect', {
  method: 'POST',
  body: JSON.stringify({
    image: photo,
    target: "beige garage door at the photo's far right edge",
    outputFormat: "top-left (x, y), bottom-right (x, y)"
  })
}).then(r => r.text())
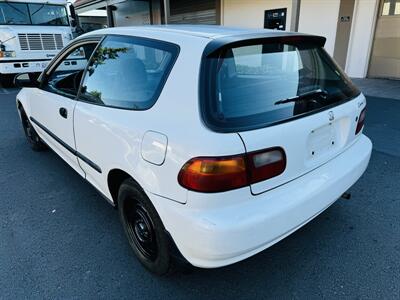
top-left (368, 0), bottom-right (400, 79)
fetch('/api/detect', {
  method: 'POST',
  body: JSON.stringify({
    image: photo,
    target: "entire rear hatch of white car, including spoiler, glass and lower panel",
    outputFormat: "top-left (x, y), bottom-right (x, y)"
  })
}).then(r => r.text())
top-left (201, 35), bottom-right (365, 194)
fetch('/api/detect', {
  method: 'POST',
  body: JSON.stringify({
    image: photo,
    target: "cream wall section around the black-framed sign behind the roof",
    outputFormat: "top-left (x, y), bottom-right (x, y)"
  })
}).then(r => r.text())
top-left (221, 0), bottom-right (292, 30)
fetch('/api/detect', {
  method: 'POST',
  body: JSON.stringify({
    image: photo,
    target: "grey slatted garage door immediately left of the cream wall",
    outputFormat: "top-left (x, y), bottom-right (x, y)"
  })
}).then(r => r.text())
top-left (168, 0), bottom-right (219, 24)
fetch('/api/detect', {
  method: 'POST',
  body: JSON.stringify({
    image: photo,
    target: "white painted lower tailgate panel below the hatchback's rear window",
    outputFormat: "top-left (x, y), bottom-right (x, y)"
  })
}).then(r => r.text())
top-left (239, 95), bottom-right (364, 194)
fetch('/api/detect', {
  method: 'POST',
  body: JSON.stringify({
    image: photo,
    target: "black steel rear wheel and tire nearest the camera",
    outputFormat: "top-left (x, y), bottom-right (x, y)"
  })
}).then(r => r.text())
top-left (118, 179), bottom-right (173, 275)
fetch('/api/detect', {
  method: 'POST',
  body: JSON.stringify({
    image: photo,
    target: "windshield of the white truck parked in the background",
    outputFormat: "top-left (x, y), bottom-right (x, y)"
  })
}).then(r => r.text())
top-left (0, 2), bottom-right (69, 26)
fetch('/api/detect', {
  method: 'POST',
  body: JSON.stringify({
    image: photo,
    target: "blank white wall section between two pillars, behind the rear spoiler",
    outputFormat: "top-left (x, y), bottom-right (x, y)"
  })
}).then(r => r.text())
top-left (299, 0), bottom-right (340, 56)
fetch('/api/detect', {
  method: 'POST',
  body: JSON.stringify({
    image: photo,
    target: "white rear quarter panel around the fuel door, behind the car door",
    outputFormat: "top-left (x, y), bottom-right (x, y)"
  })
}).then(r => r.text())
top-left (74, 35), bottom-right (244, 203)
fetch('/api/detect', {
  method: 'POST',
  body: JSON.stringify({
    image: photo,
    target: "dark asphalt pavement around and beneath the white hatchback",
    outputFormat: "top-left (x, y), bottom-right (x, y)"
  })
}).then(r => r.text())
top-left (0, 88), bottom-right (400, 299)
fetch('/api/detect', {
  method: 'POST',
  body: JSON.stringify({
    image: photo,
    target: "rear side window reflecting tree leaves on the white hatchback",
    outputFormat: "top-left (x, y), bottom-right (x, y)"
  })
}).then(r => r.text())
top-left (80, 36), bottom-right (178, 110)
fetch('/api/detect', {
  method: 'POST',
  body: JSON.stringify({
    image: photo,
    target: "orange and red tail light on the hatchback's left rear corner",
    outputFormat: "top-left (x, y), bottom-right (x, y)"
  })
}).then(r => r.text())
top-left (178, 148), bottom-right (286, 193)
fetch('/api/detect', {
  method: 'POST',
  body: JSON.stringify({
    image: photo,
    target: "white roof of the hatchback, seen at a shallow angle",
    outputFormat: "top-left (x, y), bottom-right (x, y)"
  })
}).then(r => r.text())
top-left (82, 25), bottom-right (293, 39)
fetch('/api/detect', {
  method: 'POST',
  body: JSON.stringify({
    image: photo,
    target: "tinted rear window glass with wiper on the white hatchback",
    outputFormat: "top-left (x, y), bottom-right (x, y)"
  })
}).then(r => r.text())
top-left (202, 40), bottom-right (359, 131)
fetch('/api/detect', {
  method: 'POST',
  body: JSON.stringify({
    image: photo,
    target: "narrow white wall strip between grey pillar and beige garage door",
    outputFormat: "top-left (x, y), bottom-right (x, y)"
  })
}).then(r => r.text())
top-left (346, 0), bottom-right (379, 78)
